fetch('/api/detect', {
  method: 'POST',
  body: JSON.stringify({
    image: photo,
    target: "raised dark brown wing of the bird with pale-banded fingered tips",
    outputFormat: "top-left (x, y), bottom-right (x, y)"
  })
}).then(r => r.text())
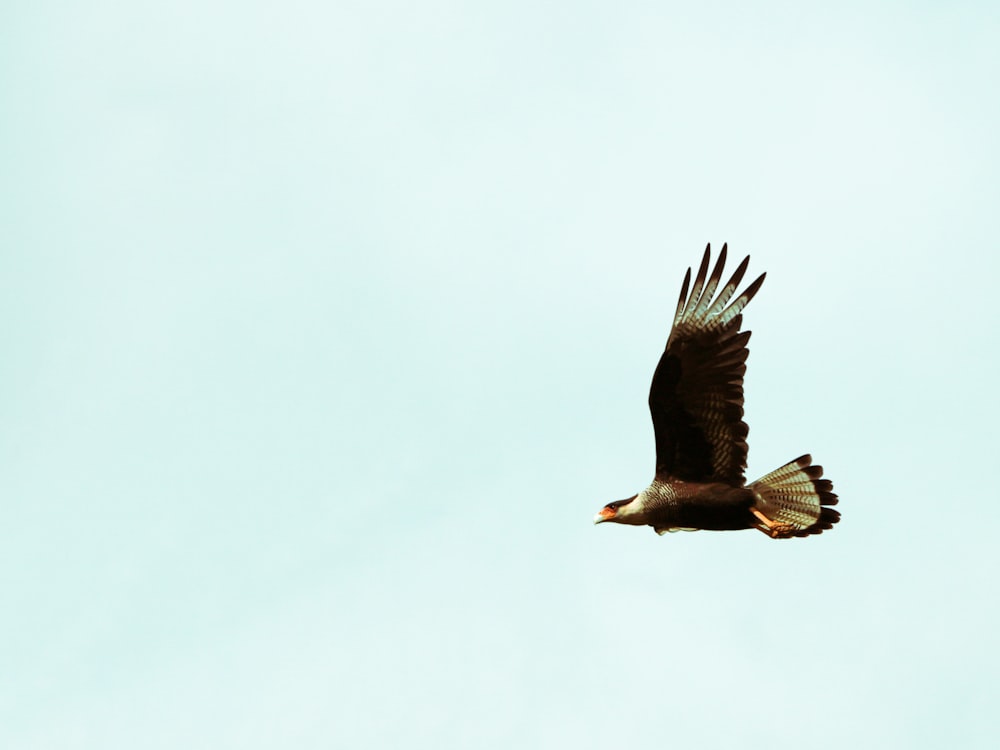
top-left (649, 245), bottom-right (765, 486)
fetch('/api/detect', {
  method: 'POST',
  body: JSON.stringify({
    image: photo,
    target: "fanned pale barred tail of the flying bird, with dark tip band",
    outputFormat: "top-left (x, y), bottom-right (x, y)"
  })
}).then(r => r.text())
top-left (750, 454), bottom-right (840, 536)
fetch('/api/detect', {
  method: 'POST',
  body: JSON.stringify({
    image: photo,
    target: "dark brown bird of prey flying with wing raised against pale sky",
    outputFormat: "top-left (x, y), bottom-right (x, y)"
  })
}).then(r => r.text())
top-left (594, 243), bottom-right (840, 539)
